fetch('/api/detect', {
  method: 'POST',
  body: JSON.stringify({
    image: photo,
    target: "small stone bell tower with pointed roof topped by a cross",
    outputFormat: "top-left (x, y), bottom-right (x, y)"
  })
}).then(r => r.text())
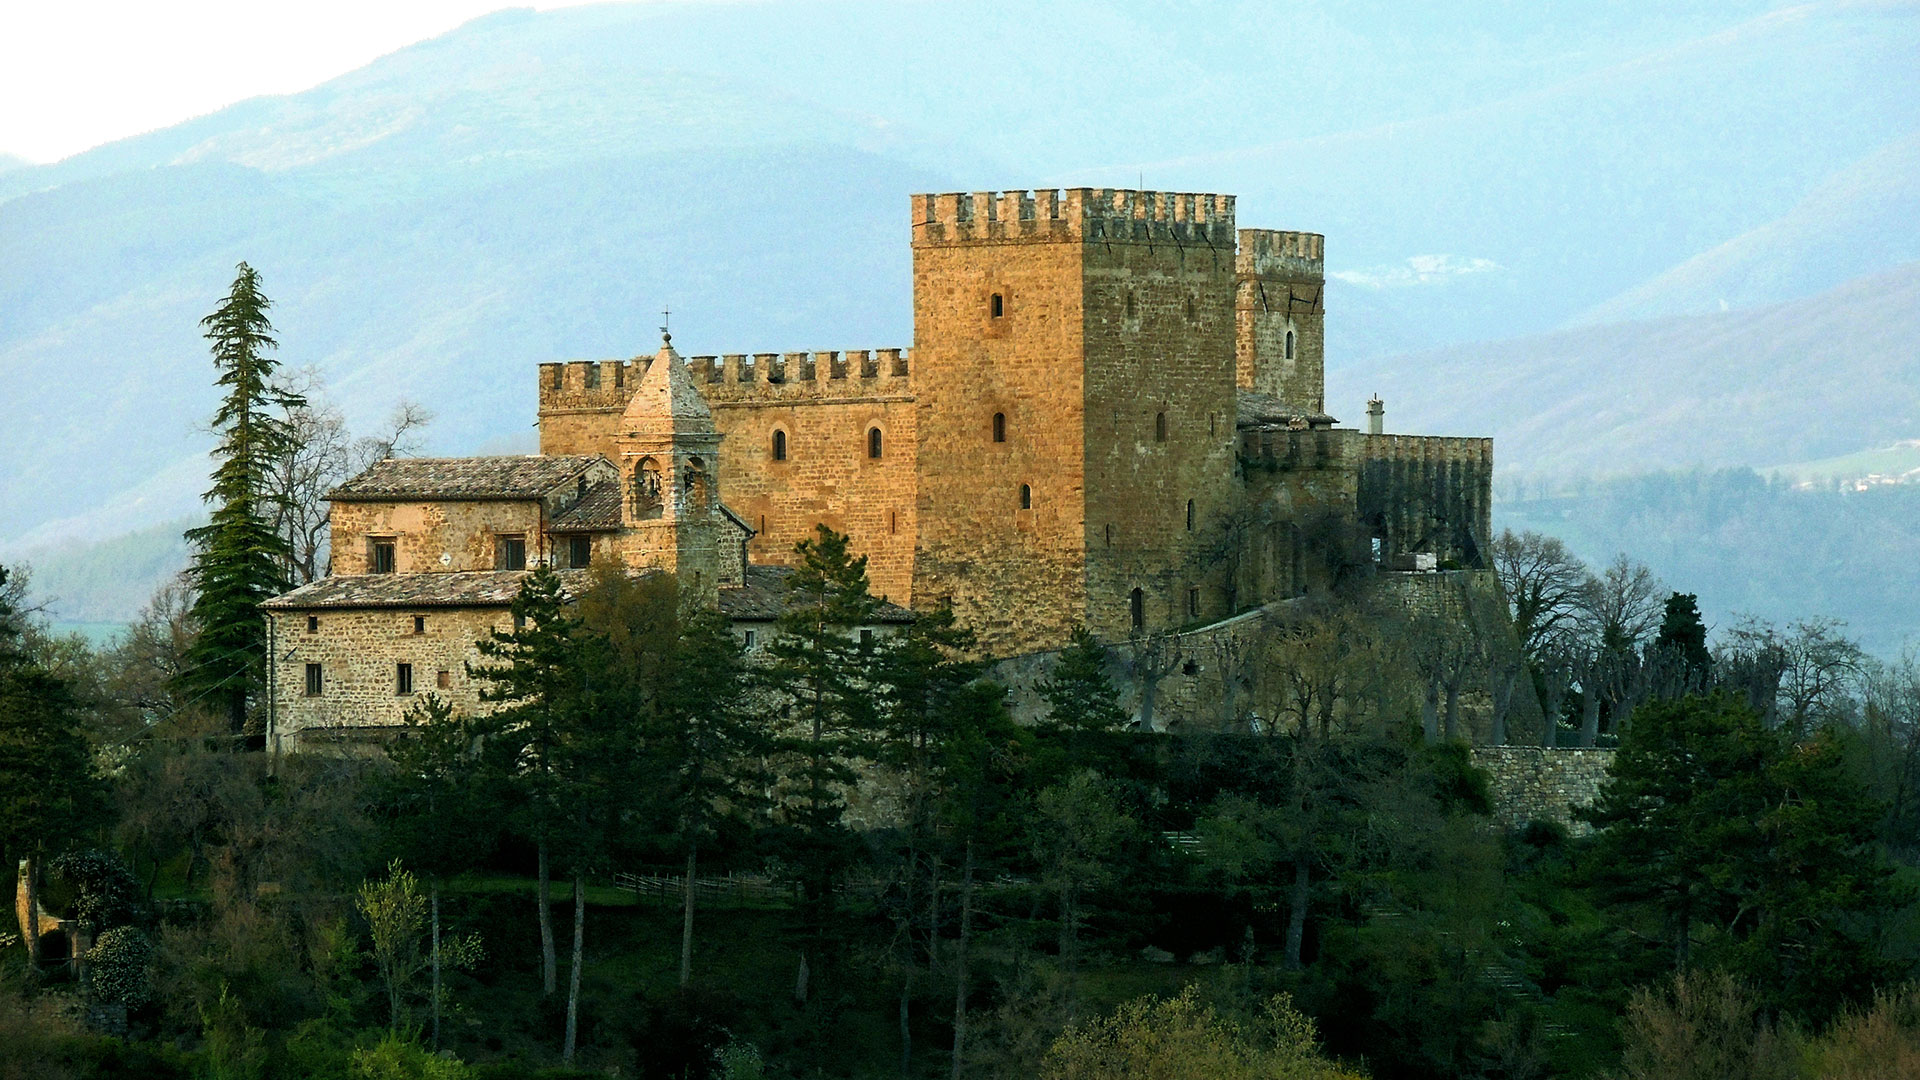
top-left (614, 331), bottom-right (726, 603)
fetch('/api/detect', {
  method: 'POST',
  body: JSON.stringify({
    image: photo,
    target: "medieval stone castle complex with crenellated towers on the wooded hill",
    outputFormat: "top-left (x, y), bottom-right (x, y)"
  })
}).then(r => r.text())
top-left (267, 188), bottom-right (1492, 742)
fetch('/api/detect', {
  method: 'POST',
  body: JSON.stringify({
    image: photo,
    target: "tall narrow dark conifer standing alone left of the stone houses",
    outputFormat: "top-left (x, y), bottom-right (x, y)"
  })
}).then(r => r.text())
top-left (179, 263), bottom-right (305, 734)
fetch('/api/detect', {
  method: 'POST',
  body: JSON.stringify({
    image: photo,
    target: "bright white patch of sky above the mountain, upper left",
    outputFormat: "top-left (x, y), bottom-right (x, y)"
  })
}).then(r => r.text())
top-left (0, 0), bottom-right (599, 161)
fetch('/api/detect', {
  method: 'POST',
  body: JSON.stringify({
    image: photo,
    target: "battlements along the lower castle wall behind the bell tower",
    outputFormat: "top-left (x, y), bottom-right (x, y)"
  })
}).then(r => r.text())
top-left (540, 348), bottom-right (910, 413)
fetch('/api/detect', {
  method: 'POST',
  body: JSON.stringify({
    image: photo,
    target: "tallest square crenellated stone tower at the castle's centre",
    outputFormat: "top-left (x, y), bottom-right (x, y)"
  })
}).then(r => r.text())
top-left (912, 188), bottom-right (1236, 653)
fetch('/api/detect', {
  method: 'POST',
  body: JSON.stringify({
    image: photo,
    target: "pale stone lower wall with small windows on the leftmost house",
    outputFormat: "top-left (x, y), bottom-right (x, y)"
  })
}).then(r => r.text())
top-left (273, 607), bottom-right (513, 749)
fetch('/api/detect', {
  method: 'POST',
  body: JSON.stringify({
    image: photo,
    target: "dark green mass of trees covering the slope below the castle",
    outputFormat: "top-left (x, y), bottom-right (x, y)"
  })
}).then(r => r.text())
top-left (0, 499), bottom-right (1920, 1080)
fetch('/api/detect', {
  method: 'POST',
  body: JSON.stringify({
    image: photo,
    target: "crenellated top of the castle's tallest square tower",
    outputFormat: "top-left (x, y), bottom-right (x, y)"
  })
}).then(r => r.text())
top-left (912, 188), bottom-right (1235, 250)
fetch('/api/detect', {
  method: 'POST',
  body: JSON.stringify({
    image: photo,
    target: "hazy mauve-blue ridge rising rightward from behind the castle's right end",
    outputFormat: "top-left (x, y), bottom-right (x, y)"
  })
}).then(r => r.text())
top-left (1327, 263), bottom-right (1920, 475)
